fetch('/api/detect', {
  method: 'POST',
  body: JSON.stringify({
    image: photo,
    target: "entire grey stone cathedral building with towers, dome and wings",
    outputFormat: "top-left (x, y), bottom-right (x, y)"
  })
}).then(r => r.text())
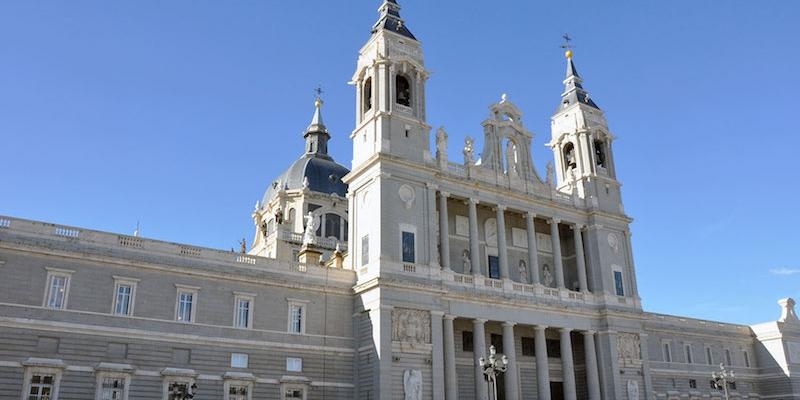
top-left (0, 0), bottom-right (800, 400)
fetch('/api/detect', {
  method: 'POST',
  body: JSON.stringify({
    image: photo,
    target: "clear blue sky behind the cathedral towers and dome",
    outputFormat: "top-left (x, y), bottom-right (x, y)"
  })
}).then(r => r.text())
top-left (0, 0), bottom-right (800, 323)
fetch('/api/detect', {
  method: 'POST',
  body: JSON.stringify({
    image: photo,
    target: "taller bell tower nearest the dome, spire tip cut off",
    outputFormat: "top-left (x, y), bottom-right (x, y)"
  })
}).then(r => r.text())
top-left (351, 0), bottom-right (431, 169)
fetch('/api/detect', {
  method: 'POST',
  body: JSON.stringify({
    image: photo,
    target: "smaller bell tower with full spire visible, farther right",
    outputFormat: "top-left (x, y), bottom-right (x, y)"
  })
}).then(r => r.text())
top-left (548, 50), bottom-right (624, 214)
